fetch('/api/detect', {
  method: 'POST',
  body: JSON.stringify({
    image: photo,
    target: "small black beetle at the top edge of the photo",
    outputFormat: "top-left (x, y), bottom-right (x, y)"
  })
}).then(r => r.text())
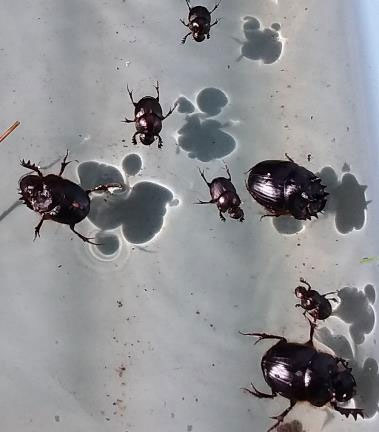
top-left (180, 0), bottom-right (221, 44)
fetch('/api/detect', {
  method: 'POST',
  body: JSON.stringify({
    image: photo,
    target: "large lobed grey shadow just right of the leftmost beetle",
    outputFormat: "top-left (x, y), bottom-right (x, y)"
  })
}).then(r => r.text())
top-left (78, 155), bottom-right (177, 246)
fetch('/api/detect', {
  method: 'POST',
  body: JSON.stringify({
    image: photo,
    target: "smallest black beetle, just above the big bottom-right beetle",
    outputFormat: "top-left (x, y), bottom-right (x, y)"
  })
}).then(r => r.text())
top-left (295, 278), bottom-right (338, 322)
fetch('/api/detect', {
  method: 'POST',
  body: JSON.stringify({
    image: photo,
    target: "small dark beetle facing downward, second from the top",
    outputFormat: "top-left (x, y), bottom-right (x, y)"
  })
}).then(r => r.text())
top-left (122, 82), bottom-right (177, 148)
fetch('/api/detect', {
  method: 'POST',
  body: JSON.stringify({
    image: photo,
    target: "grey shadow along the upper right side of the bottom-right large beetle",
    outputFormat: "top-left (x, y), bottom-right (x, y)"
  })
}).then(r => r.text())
top-left (317, 327), bottom-right (379, 418)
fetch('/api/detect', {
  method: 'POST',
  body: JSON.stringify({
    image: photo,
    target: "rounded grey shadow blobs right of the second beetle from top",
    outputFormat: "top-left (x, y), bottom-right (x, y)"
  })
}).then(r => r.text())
top-left (178, 88), bottom-right (236, 162)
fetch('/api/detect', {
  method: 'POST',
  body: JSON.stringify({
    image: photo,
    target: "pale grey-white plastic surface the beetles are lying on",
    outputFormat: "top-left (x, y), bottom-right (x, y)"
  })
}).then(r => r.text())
top-left (0, 0), bottom-right (379, 432)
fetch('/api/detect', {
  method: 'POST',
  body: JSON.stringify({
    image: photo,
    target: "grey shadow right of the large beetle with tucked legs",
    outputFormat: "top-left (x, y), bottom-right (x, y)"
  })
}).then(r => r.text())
top-left (319, 167), bottom-right (369, 234)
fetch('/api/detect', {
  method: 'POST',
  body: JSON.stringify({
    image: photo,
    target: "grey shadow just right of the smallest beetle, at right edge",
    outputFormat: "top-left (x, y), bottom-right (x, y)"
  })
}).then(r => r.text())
top-left (333, 285), bottom-right (376, 345)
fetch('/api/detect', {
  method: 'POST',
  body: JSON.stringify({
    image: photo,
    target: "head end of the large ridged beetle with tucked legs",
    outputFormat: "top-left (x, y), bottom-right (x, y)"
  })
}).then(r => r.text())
top-left (289, 177), bottom-right (329, 220)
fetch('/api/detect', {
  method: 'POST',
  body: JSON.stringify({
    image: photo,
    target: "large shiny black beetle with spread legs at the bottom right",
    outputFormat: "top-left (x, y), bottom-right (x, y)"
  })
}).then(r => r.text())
top-left (240, 321), bottom-right (363, 432)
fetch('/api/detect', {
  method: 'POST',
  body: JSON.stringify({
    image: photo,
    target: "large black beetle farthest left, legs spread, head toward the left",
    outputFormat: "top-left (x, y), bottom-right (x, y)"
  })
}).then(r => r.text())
top-left (19, 152), bottom-right (122, 244)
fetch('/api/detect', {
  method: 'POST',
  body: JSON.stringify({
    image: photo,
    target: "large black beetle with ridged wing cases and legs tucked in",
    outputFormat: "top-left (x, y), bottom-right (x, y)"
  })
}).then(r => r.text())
top-left (246, 154), bottom-right (329, 220)
